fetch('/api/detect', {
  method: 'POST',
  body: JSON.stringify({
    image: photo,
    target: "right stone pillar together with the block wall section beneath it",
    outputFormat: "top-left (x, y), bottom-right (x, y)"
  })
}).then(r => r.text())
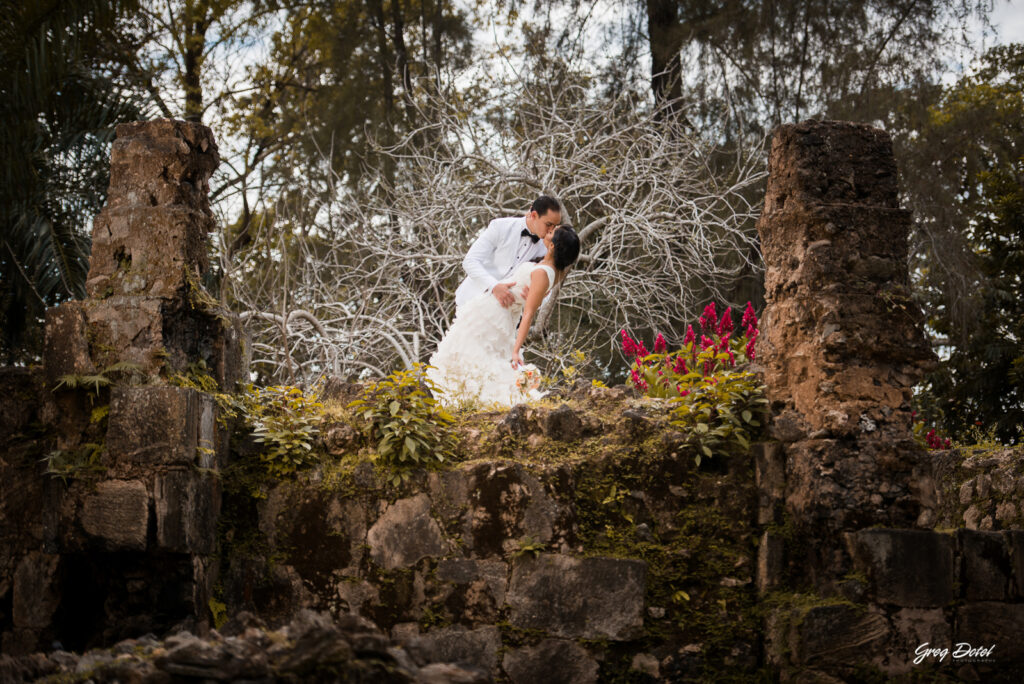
top-left (758, 122), bottom-right (1024, 681)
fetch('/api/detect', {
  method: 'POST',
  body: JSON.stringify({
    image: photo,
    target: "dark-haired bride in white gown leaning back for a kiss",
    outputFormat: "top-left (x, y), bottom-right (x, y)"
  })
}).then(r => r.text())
top-left (427, 225), bottom-right (580, 407)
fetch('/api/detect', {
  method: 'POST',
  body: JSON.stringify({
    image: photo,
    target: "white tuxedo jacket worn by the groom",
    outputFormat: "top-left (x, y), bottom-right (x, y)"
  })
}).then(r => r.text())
top-left (455, 216), bottom-right (547, 307)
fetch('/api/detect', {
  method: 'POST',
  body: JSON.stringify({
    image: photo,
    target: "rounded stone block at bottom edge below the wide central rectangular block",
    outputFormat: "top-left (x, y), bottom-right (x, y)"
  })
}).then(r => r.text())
top-left (502, 639), bottom-right (598, 684)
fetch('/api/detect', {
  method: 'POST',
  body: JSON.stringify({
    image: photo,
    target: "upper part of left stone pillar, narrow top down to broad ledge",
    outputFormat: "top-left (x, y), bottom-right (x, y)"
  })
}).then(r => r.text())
top-left (46, 120), bottom-right (242, 388)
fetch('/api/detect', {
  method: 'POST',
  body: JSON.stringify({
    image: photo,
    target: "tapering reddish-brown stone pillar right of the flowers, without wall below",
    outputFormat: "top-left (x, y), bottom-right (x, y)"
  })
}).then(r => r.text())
top-left (758, 121), bottom-right (934, 548)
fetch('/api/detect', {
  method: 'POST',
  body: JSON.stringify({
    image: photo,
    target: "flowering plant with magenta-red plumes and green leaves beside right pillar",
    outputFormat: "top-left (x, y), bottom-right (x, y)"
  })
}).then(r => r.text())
top-left (621, 302), bottom-right (768, 465)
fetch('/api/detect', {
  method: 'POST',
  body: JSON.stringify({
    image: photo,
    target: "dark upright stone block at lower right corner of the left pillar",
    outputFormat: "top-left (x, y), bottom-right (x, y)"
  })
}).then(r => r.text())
top-left (153, 470), bottom-right (220, 554)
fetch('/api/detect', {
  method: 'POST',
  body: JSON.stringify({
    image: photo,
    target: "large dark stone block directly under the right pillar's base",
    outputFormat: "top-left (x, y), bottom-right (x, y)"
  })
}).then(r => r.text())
top-left (851, 528), bottom-right (954, 608)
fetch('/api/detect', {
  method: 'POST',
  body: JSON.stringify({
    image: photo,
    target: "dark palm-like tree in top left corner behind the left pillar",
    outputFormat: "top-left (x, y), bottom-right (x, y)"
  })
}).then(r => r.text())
top-left (0, 0), bottom-right (144, 362)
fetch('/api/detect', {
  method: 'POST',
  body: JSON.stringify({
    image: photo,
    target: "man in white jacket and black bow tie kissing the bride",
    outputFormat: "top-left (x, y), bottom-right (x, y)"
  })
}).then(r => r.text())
top-left (455, 195), bottom-right (562, 308)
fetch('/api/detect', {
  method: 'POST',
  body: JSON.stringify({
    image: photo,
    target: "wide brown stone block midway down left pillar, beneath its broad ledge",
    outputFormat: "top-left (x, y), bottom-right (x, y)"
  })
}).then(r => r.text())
top-left (106, 385), bottom-right (212, 467)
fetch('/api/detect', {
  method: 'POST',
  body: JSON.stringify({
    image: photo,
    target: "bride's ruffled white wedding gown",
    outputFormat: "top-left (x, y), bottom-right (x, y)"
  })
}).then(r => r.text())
top-left (427, 262), bottom-right (555, 407)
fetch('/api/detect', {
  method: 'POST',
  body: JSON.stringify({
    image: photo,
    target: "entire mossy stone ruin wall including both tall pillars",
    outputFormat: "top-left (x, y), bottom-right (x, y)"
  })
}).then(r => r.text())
top-left (0, 121), bottom-right (1024, 681)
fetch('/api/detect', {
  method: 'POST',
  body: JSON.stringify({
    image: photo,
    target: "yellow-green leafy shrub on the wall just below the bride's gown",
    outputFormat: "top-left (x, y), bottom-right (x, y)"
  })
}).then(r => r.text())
top-left (349, 364), bottom-right (456, 484)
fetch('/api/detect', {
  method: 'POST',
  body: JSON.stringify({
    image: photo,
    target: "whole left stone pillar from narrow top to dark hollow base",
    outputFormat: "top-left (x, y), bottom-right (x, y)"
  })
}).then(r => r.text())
top-left (11, 120), bottom-right (243, 650)
